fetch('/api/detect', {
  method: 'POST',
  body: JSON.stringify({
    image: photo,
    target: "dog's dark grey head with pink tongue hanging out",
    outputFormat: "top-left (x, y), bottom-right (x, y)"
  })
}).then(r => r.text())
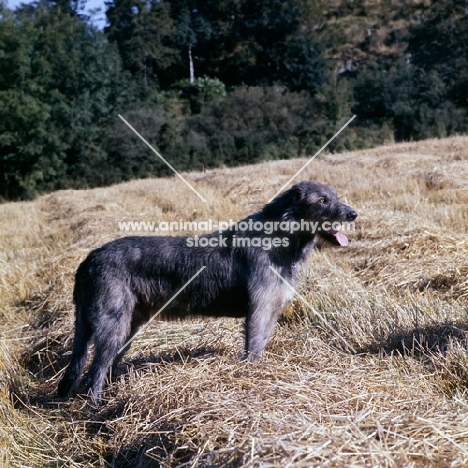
top-left (263, 180), bottom-right (357, 247)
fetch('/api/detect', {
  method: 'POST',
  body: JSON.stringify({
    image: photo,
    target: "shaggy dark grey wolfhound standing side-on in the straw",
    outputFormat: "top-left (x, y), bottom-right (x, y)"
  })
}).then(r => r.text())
top-left (58, 181), bottom-right (357, 401)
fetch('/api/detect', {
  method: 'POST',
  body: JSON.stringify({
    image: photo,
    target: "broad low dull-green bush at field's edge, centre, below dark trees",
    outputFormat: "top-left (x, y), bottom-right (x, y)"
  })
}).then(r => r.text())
top-left (188, 87), bottom-right (352, 167)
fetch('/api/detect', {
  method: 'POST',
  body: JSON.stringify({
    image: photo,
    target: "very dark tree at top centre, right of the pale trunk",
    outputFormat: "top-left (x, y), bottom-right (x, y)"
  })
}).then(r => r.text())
top-left (211, 0), bottom-right (327, 93)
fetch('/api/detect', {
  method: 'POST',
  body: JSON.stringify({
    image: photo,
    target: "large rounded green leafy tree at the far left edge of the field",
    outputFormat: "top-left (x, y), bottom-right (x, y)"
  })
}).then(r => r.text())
top-left (0, 7), bottom-right (135, 198)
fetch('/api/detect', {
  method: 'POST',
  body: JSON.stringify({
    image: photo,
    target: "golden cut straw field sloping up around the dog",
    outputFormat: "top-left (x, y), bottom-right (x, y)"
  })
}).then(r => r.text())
top-left (0, 137), bottom-right (468, 468)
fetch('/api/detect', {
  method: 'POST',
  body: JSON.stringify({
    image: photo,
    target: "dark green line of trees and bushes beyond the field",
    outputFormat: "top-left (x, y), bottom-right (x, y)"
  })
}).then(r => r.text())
top-left (0, 0), bottom-right (468, 200)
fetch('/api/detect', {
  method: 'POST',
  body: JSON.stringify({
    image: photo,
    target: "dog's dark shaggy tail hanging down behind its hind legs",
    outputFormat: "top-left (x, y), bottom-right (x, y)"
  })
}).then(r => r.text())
top-left (58, 304), bottom-right (93, 398)
